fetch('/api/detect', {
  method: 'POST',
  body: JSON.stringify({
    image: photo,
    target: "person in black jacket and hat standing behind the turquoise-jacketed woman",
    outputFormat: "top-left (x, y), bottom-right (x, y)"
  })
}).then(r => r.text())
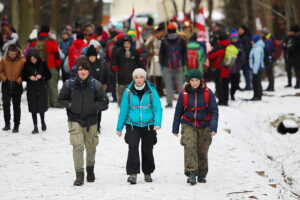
top-left (112, 35), bottom-right (144, 106)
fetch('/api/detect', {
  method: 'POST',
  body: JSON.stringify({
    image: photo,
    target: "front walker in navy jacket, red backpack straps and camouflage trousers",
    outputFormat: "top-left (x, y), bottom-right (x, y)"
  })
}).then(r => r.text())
top-left (172, 70), bottom-right (219, 185)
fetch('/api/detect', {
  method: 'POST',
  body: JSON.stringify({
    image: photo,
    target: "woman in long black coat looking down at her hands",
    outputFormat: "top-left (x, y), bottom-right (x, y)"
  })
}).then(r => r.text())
top-left (22, 49), bottom-right (51, 134)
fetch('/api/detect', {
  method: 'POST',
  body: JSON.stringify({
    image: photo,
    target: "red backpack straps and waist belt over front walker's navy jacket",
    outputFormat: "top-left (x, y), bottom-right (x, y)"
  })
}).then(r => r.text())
top-left (182, 87), bottom-right (211, 127)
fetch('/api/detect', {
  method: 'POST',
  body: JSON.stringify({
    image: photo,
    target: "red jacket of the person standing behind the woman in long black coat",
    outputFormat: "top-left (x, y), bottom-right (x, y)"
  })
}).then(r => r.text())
top-left (30, 33), bottom-right (61, 68)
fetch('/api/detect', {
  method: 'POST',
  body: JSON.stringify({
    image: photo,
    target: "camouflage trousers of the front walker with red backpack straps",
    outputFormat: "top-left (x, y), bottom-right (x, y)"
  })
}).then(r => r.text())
top-left (180, 124), bottom-right (212, 177)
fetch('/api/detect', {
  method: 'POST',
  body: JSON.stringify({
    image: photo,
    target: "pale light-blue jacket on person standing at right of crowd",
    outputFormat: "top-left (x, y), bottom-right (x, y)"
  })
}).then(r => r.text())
top-left (249, 40), bottom-right (265, 74)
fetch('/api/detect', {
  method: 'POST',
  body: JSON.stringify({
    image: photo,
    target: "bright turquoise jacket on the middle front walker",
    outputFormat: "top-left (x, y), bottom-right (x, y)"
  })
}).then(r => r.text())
top-left (117, 81), bottom-right (162, 131)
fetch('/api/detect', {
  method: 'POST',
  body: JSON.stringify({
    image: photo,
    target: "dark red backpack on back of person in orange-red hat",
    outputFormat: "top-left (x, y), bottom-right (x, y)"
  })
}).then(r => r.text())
top-left (165, 39), bottom-right (181, 69)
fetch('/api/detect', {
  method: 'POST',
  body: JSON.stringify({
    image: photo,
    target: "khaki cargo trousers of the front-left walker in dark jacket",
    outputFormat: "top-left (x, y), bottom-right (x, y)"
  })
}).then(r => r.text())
top-left (69, 121), bottom-right (99, 172)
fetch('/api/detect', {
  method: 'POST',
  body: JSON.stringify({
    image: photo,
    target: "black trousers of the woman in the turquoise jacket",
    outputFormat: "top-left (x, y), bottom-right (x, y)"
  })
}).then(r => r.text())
top-left (125, 125), bottom-right (157, 175)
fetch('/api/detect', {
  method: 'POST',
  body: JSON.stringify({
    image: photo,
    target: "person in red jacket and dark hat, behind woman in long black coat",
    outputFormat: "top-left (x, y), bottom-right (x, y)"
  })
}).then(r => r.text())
top-left (32, 25), bottom-right (61, 108)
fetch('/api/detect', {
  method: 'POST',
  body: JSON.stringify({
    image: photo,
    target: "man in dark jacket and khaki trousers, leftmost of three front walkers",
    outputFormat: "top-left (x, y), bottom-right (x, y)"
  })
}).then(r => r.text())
top-left (58, 59), bottom-right (108, 186)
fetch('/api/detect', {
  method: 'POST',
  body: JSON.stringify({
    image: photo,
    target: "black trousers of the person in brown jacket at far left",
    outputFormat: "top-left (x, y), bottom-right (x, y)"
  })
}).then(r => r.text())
top-left (2, 84), bottom-right (23, 126)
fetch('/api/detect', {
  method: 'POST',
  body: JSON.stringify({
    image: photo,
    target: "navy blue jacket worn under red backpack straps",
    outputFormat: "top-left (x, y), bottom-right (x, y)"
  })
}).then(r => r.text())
top-left (172, 84), bottom-right (219, 133)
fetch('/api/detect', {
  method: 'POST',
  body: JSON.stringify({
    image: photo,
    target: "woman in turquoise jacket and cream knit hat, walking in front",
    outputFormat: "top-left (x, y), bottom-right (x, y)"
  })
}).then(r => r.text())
top-left (116, 68), bottom-right (162, 184)
